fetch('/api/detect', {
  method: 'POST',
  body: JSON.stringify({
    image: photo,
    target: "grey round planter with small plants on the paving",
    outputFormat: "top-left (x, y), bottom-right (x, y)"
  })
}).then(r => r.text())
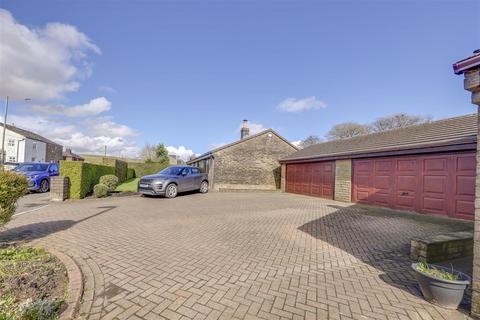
top-left (412, 262), bottom-right (472, 309)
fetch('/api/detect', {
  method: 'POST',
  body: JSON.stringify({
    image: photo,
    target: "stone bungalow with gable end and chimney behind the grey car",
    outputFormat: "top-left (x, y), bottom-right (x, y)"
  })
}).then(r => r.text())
top-left (187, 120), bottom-right (298, 191)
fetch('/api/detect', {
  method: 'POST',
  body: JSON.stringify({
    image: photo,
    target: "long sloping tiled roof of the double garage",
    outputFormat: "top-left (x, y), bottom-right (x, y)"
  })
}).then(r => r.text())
top-left (280, 114), bottom-right (477, 162)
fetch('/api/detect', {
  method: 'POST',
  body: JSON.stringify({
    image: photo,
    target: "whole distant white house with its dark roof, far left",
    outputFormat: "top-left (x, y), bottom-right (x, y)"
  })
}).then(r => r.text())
top-left (0, 123), bottom-right (63, 162)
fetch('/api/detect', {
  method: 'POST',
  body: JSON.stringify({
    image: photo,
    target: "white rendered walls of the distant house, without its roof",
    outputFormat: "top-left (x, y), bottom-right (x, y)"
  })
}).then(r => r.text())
top-left (0, 125), bottom-right (47, 162)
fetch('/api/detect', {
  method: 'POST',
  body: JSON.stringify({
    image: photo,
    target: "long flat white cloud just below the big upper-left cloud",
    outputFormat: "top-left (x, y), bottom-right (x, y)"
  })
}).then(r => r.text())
top-left (25, 97), bottom-right (112, 117)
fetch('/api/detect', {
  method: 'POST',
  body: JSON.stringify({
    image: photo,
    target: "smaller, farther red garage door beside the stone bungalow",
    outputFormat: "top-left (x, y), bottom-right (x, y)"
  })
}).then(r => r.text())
top-left (285, 161), bottom-right (335, 199)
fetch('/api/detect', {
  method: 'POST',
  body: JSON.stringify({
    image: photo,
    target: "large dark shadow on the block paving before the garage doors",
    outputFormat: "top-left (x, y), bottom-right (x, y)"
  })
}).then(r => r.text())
top-left (298, 205), bottom-right (473, 310)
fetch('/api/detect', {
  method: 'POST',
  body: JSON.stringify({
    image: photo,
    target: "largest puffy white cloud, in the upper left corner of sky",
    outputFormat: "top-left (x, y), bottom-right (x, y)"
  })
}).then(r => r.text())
top-left (0, 9), bottom-right (101, 100)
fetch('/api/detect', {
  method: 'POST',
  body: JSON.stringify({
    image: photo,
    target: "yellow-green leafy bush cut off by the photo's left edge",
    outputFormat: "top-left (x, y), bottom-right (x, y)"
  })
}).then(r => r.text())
top-left (0, 171), bottom-right (28, 226)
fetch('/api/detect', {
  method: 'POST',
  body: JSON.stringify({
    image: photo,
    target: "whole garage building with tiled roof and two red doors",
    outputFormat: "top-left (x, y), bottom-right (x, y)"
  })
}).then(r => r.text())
top-left (280, 114), bottom-right (477, 220)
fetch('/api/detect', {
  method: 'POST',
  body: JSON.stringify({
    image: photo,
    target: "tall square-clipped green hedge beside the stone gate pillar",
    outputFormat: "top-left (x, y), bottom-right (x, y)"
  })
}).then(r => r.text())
top-left (60, 160), bottom-right (116, 199)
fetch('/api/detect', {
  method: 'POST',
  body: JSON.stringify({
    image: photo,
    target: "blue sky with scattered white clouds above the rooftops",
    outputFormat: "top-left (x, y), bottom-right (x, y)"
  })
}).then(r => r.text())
top-left (0, 0), bottom-right (480, 159)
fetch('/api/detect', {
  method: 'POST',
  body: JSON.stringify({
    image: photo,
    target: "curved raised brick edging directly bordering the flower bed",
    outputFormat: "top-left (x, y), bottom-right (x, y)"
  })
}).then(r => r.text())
top-left (47, 248), bottom-right (83, 320)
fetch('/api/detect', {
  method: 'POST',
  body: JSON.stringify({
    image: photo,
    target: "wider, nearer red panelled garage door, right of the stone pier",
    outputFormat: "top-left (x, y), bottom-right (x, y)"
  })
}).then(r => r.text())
top-left (353, 153), bottom-right (476, 220)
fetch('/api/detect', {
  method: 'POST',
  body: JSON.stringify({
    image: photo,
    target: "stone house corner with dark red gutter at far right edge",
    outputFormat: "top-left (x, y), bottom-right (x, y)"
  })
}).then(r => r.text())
top-left (453, 50), bottom-right (480, 318)
